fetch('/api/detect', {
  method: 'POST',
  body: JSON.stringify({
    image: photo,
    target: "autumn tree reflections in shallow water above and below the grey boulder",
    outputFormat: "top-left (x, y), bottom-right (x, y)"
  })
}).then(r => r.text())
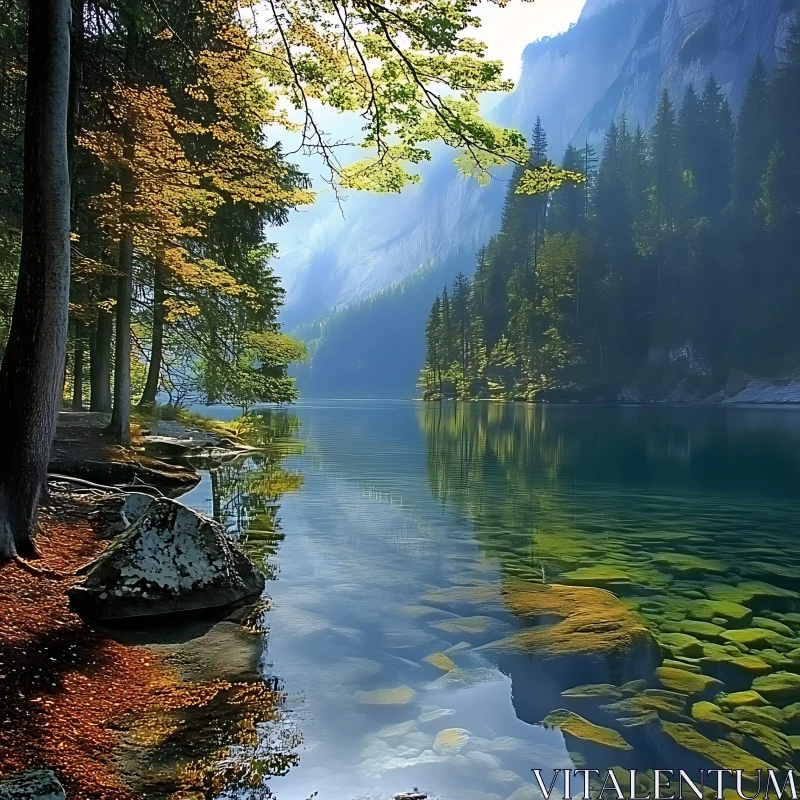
top-left (119, 410), bottom-right (303, 800)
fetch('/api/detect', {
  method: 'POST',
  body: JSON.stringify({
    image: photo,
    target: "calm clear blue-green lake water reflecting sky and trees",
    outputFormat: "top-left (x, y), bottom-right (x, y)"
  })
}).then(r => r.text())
top-left (184, 401), bottom-right (800, 800)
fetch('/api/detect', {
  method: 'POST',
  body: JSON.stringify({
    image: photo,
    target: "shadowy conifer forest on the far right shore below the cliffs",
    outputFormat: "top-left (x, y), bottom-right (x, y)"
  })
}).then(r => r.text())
top-left (419, 26), bottom-right (800, 401)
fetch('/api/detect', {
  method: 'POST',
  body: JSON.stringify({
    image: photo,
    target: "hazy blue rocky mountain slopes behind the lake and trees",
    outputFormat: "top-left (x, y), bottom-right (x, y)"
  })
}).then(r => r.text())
top-left (284, 0), bottom-right (800, 395)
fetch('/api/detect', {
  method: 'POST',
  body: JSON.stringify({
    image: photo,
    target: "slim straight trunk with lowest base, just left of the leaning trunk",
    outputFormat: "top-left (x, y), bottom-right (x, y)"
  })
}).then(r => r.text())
top-left (109, 20), bottom-right (136, 447)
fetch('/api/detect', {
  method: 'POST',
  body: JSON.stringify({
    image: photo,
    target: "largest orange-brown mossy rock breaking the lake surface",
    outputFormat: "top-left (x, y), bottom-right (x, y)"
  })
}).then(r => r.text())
top-left (490, 581), bottom-right (661, 674)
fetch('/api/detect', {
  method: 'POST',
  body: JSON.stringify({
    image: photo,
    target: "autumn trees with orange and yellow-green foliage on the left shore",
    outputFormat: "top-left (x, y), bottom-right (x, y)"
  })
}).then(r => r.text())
top-left (0, 0), bottom-right (556, 555)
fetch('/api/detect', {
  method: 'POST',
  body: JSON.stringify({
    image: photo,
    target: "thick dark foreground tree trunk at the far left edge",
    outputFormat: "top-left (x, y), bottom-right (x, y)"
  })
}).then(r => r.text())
top-left (0, 0), bottom-right (70, 557)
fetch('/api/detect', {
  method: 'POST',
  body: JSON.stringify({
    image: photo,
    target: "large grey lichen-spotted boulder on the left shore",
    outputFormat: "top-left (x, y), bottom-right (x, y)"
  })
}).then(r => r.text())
top-left (70, 498), bottom-right (264, 620)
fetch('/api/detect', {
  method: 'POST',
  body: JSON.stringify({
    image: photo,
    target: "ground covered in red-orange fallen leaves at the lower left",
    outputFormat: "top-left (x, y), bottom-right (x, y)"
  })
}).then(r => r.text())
top-left (0, 490), bottom-right (165, 798)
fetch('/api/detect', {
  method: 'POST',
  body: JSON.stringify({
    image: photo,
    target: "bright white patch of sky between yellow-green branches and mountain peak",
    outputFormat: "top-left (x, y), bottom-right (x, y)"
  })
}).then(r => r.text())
top-left (475, 0), bottom-right (586, 81)
